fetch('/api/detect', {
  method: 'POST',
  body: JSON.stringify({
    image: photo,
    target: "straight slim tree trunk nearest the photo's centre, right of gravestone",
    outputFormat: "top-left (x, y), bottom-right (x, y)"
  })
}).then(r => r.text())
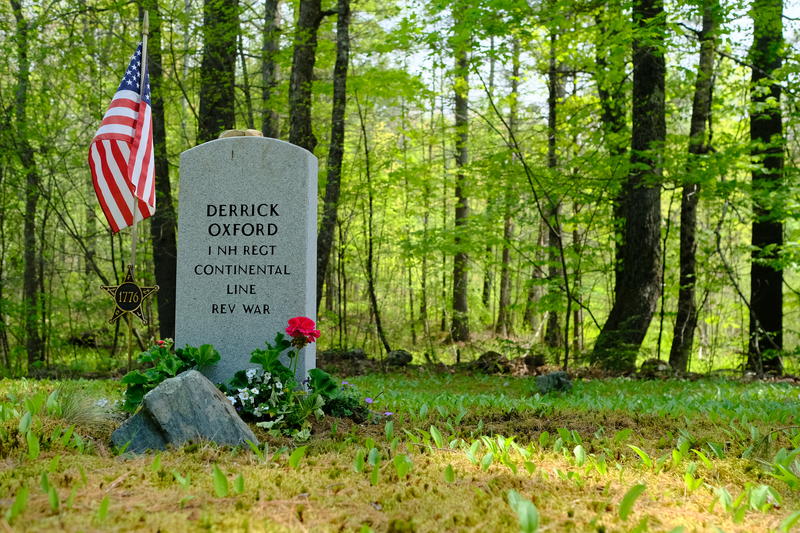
top-left (450, 13), bottom-right (469, 342)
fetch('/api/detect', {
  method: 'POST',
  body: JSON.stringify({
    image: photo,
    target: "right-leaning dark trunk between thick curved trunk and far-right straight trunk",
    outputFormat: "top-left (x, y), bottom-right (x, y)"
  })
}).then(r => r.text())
top-left (669, 0), bottom-right (720, 372)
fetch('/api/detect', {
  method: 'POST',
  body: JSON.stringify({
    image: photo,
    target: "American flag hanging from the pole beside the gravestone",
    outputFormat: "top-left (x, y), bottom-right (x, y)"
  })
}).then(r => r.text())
top-left (89, 44), bottom-right (156, 233)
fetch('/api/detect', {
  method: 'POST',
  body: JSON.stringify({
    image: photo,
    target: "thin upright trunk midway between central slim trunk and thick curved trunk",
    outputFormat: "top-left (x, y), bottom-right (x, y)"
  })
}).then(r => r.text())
top-left (544, 32), bottom-right (566, 348)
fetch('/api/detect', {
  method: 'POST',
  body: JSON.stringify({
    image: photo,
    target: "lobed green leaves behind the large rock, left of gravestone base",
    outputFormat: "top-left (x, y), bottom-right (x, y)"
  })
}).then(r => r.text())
top-left (122, 339), bottom-right (220, 413)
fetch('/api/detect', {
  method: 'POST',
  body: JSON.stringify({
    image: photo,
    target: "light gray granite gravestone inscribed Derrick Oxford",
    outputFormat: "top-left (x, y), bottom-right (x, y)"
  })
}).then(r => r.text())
top-left (175, 137), bottom-right (317, 383)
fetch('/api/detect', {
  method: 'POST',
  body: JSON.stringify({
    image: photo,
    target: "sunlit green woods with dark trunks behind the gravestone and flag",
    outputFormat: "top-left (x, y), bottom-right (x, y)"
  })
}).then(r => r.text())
top-left (0, 0), bottom-right (800, 375)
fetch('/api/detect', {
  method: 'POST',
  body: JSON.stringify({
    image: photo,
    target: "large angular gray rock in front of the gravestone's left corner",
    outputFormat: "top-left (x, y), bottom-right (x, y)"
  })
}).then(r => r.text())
top-left (111, 370), bottom-right (258, 453)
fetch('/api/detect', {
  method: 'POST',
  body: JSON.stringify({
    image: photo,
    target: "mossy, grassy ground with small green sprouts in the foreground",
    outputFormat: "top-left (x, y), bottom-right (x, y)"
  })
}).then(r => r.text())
top-left (0, 372), bottom-right (800, 532)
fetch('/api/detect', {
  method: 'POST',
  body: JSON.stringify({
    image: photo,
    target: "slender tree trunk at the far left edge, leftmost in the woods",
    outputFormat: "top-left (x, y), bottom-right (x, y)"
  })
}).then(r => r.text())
top-left (11, 0), bottom-right (44, 372)
